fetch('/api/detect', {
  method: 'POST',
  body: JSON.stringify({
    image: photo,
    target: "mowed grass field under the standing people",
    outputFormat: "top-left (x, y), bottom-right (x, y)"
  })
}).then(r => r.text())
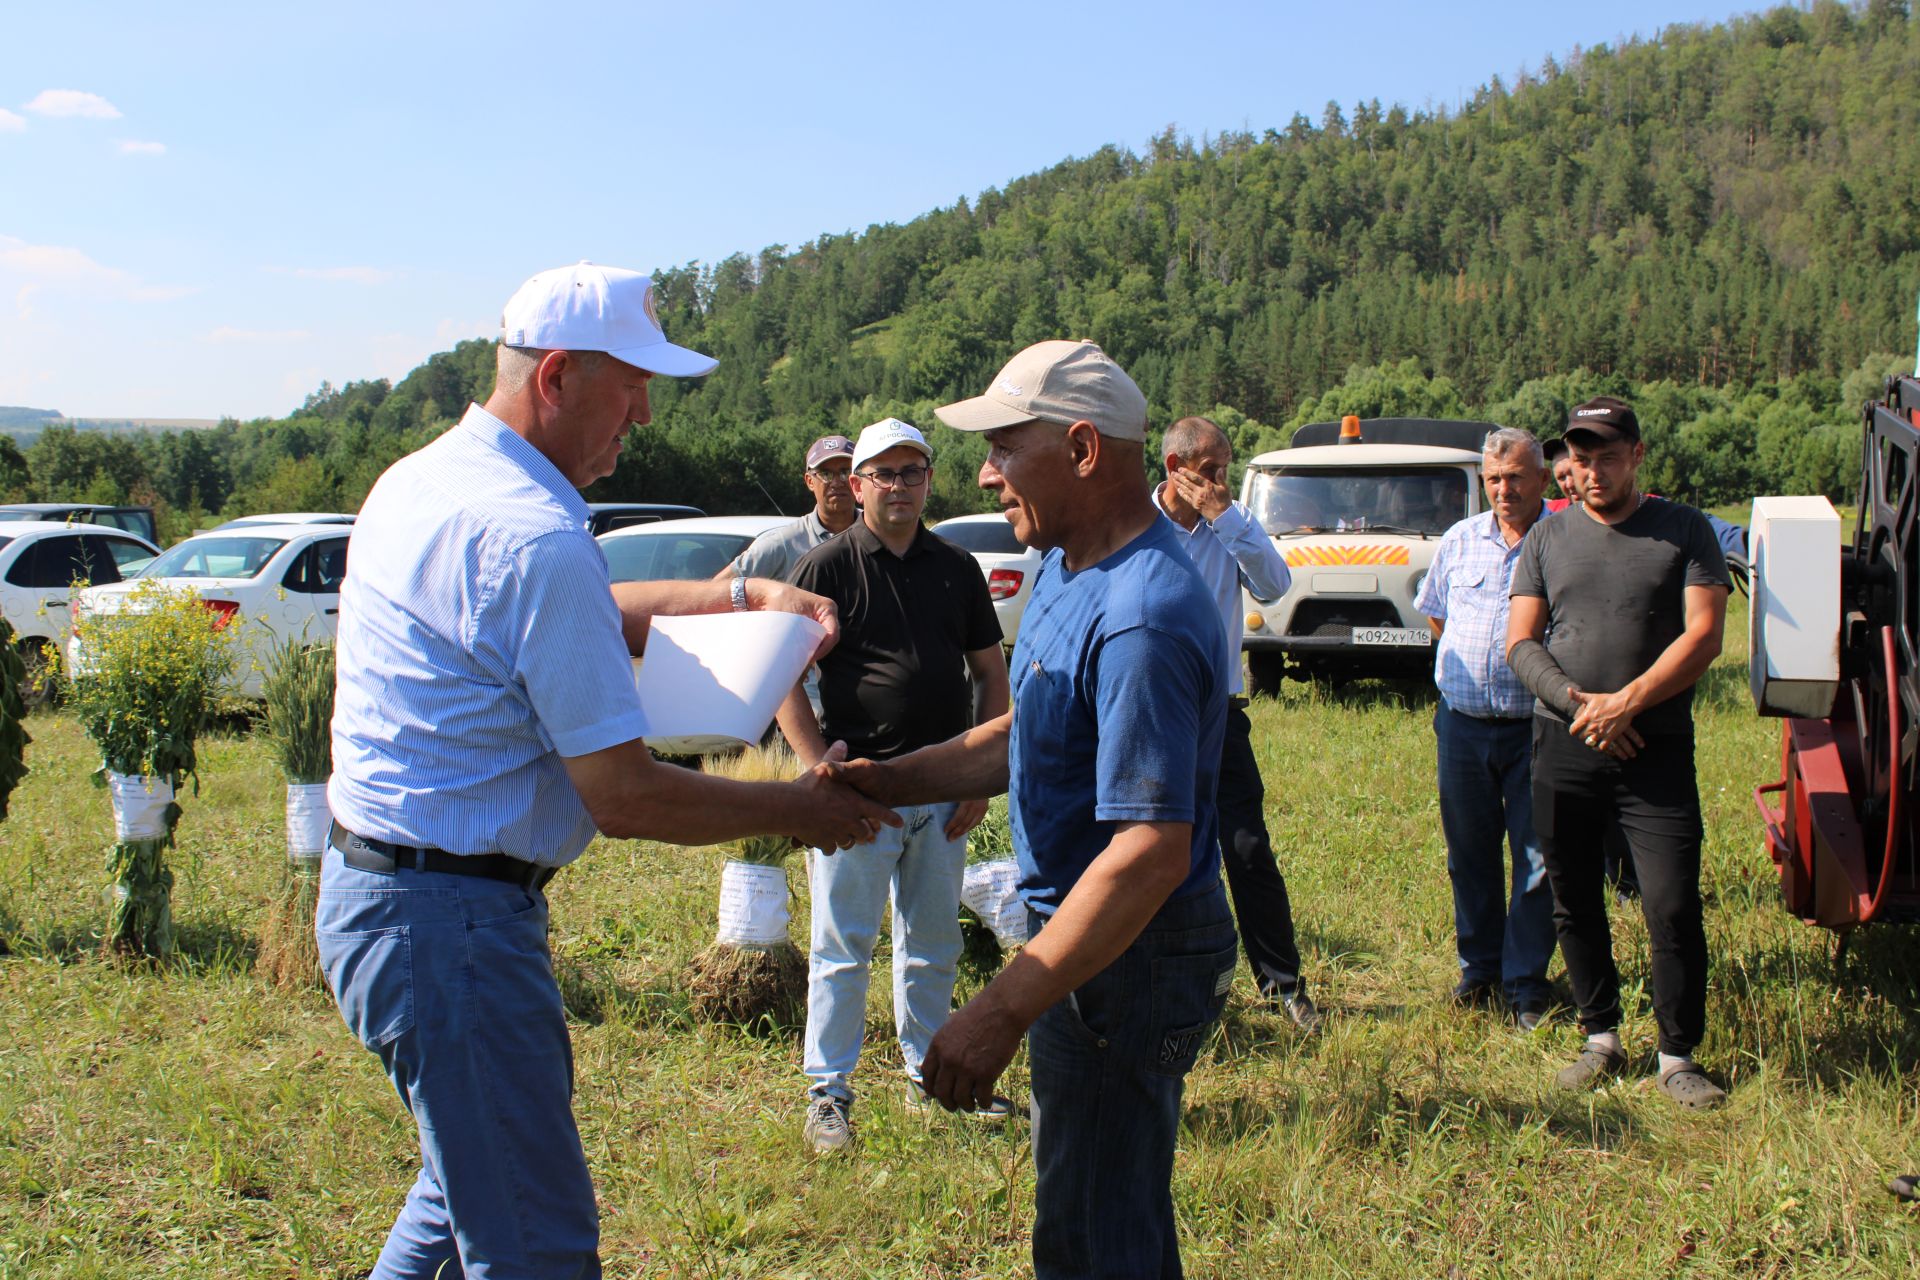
top-left (0, 597), bottom-right (1920, 1280)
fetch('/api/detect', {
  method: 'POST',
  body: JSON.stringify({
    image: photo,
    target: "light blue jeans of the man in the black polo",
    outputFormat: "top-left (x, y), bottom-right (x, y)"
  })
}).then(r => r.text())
top-left (801, 804), bottom-right (966, 1102)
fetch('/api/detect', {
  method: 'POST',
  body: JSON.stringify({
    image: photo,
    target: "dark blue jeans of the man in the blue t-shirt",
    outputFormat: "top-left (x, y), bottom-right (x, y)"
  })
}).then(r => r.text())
top-left (1027, 885), bottom-right (1238, 1280)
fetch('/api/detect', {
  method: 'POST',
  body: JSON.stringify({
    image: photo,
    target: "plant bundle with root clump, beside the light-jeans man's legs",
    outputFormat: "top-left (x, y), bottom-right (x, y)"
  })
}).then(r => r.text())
top-left (685, 748), bottom-right (806, 1029)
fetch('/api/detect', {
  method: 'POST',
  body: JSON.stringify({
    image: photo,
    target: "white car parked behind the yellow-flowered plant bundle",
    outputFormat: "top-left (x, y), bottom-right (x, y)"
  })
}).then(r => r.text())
top-left (67, 524), bottom-right (348, 699)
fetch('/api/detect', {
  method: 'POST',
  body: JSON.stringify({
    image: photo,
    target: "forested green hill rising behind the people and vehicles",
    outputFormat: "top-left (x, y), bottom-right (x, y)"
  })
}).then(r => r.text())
top-left (0, 0), bottom-right (1920, 529)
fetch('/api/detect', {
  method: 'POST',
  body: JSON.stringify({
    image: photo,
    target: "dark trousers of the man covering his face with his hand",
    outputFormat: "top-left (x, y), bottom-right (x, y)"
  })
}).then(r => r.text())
top-left (1217, 706), bottom-right (1306, 1000)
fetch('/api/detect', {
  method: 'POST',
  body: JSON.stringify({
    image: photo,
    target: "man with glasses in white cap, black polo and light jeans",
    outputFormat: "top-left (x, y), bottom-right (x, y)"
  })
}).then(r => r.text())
top-left (780, 418), bottom-right (1008, 1153)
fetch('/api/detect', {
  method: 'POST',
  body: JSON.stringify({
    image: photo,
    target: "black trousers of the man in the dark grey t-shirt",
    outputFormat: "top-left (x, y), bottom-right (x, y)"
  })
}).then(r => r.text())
top-left (1534, 718), bottom-right (1707, 1057)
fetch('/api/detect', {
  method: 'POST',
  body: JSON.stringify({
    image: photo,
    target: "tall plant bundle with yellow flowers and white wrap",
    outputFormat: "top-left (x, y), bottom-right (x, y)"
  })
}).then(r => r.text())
top-left (69, 581), bottom-right (234, 960)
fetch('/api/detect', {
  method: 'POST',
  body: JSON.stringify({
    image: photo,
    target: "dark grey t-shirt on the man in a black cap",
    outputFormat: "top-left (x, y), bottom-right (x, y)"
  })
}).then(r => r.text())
top-left (1509, 497), bottom-right (1730, 733)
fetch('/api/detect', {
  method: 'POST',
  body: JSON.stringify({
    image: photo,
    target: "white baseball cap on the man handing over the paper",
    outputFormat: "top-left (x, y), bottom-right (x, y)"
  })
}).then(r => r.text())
top-left (499, 261), bottom-right (720, 378)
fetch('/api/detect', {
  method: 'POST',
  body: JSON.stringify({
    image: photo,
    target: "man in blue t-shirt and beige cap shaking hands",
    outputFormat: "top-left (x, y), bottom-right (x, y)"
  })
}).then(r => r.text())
top-left (839, 342), bottom-right (1236, 1280)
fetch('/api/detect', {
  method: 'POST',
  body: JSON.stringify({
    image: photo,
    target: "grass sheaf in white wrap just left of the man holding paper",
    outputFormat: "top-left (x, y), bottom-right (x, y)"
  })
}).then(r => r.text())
top-left (259, 639), bottom-right (334, 988)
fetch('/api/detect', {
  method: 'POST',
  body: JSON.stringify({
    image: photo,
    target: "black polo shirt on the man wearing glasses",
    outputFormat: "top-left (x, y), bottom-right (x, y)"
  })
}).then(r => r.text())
top-left (787, 520), bottom-right (1000, 760)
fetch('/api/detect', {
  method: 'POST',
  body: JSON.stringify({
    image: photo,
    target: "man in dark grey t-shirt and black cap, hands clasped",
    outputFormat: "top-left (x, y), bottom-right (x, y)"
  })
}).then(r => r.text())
top-left (1507, 395), bottom-right (1730, 1107)
